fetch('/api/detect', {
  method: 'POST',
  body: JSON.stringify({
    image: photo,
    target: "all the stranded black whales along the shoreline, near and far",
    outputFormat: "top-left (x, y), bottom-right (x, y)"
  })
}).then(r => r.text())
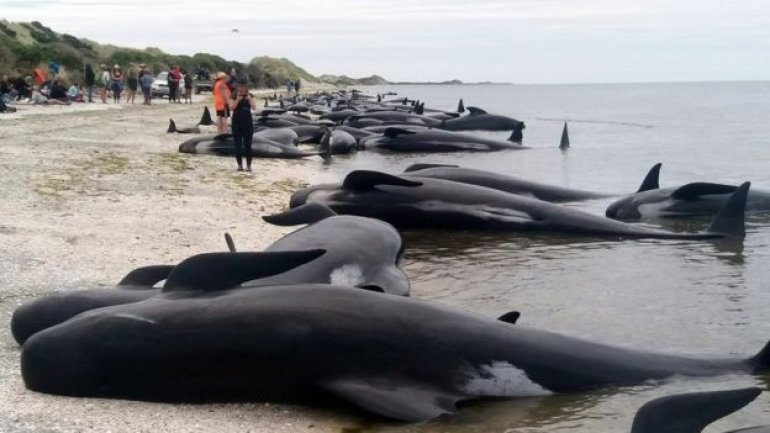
top-left (11, 88), bottom-right (770, 433)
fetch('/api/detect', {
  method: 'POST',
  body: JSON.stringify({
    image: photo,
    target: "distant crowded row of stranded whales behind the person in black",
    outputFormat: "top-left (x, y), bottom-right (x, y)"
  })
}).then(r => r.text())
top-left (168, 92), bottom-right (528, 161)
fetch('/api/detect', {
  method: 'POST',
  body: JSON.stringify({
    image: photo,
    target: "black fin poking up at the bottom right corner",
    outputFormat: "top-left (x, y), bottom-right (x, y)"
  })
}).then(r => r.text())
top-left (631, 387), bottom-right (762, 433)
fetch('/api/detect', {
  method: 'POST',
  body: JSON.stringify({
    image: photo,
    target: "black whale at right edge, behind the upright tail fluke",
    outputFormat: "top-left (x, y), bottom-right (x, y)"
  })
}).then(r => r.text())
top-left (606, 164), bottom-right (770, 220)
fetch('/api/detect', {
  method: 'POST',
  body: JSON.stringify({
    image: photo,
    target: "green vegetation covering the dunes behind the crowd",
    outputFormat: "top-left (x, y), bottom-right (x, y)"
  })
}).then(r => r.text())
top-left (0, 20), bottom-right (387, 88)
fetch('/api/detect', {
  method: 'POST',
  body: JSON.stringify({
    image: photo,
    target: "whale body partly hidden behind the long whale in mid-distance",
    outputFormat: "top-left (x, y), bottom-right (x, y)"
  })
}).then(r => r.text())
top-left (404, 164), bottom-right (612, 203)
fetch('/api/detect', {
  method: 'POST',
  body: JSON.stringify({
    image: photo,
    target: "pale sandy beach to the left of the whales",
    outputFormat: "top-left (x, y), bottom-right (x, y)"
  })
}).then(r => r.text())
top-left (0, 96), bottom-right (364, 433)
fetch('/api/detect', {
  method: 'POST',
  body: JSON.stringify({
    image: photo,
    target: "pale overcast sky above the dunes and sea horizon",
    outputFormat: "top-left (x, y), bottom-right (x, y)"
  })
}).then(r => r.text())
top-left (0, 0), bottom-right (770, 83)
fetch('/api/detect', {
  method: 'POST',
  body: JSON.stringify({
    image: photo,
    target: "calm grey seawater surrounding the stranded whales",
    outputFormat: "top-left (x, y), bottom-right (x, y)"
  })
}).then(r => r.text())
top-left (308, 82), bottom-right (770, 432)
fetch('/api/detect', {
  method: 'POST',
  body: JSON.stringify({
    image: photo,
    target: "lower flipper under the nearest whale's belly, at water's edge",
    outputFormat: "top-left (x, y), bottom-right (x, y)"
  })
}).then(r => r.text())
top-left (323, 379), bottom-right (461, 422)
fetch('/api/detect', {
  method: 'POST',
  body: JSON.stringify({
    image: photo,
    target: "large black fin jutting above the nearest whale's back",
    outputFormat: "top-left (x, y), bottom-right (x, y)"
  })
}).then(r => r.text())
top-left (162, 249), bottom-right (326, 292)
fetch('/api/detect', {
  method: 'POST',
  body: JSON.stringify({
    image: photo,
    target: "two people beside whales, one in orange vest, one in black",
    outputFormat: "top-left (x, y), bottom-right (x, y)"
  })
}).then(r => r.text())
top-left (212, 68), bottom-right (257, 171)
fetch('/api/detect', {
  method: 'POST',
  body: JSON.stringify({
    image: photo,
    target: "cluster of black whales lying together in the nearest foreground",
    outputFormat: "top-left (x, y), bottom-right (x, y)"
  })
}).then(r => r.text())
top-left (12, 203), bottom-right (770, 432)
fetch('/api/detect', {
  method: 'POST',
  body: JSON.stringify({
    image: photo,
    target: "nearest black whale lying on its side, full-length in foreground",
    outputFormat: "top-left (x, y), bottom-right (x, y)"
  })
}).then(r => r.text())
top-left (21, 285), bottom-right (770, 421)
